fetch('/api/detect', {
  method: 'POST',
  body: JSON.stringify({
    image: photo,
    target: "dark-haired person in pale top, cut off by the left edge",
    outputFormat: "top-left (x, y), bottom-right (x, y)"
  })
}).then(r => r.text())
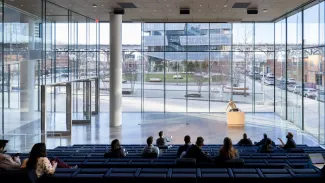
top-left (0, 140), bottom-right (21, 170)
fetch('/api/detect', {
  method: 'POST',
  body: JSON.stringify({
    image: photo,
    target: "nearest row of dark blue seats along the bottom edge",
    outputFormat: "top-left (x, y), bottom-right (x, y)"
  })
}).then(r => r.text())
top-left (0, 168), bottom-right (324, 183)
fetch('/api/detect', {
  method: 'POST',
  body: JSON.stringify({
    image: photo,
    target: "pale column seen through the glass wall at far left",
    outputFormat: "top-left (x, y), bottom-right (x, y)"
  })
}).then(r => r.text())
top-left (20, 19), bottom-right (35, 121)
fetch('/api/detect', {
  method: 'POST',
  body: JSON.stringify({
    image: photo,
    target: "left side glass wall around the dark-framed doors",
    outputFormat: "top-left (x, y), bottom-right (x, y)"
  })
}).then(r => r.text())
top-left (0, 1), bottom-right (99, 149)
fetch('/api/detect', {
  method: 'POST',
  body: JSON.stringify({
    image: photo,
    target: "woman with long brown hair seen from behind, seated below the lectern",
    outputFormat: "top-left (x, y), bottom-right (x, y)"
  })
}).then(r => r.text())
top-left (216, 137), bottom-right (238, 162)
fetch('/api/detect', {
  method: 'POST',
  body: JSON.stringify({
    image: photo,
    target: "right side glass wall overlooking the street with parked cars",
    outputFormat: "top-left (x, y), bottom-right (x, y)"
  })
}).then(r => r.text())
top-left (275, 2), bottom-right (325, 144)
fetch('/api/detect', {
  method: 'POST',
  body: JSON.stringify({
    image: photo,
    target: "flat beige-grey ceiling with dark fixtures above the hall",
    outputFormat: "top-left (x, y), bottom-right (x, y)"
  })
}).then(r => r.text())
top-left (5, 0), bottom-right (310, 22)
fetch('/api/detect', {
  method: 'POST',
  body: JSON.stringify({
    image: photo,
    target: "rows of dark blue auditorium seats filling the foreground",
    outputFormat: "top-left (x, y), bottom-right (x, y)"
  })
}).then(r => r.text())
top-left (0, 144), bottom-right (325, 183)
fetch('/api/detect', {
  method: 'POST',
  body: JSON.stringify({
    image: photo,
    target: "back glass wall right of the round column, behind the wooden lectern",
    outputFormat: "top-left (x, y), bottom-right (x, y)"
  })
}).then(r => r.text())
top-left (139, 23), bottom-right (274, 112)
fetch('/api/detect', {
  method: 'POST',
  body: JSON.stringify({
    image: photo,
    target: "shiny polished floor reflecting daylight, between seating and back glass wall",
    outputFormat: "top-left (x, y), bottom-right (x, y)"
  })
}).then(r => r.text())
top-left (1, 113), bottom-right (318, 152)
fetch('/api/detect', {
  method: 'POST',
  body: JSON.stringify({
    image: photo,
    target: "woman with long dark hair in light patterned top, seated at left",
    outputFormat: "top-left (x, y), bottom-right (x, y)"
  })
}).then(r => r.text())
top-left (21, 143), bottom-right (78, 178)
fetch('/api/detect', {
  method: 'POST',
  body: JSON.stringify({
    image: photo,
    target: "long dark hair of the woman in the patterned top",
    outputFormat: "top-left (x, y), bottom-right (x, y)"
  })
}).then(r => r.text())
top-left (26, 143), bottom-right (46, 169)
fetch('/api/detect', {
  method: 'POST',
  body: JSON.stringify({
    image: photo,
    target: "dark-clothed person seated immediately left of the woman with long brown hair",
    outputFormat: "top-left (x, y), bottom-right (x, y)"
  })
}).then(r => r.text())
top-left (183, 137), bottom-right (212, 162)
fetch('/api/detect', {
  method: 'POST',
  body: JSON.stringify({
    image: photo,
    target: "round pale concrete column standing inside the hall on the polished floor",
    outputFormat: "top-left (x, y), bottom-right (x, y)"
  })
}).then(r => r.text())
top-left (109, 13), bottom-right (122, 127)
